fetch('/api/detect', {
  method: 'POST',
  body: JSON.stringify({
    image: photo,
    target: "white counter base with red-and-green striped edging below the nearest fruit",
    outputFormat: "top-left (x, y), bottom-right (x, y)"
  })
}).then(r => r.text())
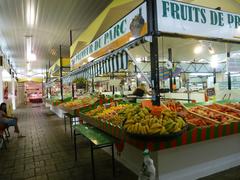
top-left (76, 100), bottom-right (240, 179)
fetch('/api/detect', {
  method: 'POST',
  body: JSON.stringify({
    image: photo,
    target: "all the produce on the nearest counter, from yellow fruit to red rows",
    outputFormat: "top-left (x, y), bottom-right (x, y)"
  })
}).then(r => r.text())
top-left (79, 97), bottom-right (240, 136)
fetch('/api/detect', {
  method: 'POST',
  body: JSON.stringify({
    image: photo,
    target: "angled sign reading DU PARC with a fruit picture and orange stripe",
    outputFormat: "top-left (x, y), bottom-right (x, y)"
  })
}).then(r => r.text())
top-left (71, 3), bottom-right (147, 70)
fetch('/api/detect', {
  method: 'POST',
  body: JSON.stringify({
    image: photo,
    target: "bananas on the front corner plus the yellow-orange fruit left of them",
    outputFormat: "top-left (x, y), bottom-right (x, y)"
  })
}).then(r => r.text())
top-left (86, 104), bottom-right (187, 136)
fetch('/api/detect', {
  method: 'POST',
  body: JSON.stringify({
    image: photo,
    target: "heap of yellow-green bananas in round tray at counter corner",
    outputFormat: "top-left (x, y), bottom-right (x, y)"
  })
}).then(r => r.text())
top-left (119, 106), bottom-right (186, 135)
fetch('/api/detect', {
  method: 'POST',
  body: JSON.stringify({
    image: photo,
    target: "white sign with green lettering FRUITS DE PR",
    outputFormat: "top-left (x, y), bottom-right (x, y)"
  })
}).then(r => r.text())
top-left (156, 0), bottom-right (240, 41)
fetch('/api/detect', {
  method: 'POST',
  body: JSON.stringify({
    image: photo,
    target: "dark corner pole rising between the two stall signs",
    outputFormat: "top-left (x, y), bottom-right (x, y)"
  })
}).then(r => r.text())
top-left (147, 0), bottom-right (160, 106)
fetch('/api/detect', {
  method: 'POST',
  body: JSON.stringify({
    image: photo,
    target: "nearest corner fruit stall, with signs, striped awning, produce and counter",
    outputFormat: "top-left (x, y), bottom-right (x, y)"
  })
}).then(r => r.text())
top-left (60, 0), bottom-right (240, 180)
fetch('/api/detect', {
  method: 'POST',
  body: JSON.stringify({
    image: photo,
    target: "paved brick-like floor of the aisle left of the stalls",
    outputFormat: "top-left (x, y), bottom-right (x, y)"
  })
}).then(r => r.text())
top-left (0, 105), bottom-right (137, 180)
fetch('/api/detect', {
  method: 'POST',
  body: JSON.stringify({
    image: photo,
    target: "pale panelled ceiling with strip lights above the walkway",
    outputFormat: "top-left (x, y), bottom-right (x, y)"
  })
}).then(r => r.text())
top-left (0, 0), bottom-right (112, 73)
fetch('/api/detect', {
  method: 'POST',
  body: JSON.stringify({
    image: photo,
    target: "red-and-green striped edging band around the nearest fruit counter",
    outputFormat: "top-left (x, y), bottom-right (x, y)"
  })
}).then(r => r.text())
top-left (80, 113), bottom-right (240, 151)
